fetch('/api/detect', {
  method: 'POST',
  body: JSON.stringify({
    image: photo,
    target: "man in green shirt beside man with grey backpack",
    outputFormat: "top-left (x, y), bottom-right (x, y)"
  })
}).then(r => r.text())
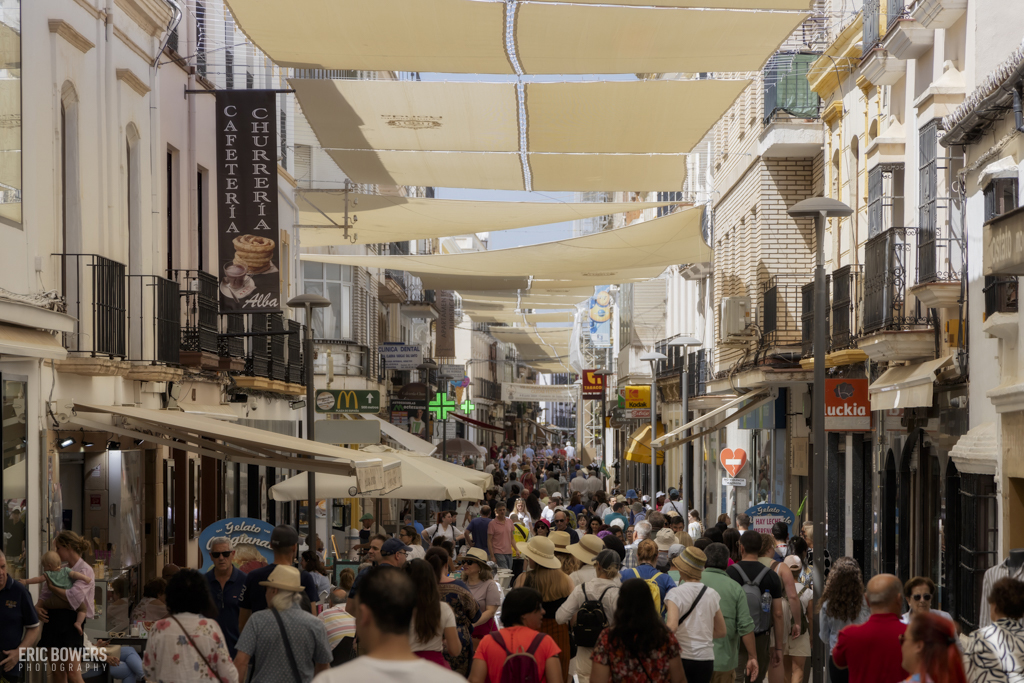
top-left (700, 543), bottom-right (758, 683)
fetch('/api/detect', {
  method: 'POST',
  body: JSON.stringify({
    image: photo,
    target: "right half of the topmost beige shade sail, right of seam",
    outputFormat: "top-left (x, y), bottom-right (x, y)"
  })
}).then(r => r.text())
top-left (516, 2), bottom-right (808, 74)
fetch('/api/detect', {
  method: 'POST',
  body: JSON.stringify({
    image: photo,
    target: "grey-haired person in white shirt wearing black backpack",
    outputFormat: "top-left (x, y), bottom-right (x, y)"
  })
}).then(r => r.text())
top-left (555, 548), bottom-right (623, 683)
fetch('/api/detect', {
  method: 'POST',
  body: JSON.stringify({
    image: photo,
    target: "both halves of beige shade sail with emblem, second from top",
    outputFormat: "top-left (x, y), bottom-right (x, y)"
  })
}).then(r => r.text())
top-left (289, 79), bottom-right (751, 154)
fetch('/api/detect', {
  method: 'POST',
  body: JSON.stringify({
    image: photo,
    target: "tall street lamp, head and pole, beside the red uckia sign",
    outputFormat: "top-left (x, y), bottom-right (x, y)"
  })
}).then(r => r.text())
top-left (787, 197), bottom-right (853, 681)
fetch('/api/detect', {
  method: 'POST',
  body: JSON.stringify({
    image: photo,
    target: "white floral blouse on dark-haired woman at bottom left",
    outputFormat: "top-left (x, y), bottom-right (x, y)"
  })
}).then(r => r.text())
top-left (142, 612), bottom-right (239, 683)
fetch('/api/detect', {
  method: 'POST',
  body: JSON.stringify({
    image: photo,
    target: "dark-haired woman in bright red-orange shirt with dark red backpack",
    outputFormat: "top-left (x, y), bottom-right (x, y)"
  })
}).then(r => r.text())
top-left (469, 588), bottom-right (565, 683)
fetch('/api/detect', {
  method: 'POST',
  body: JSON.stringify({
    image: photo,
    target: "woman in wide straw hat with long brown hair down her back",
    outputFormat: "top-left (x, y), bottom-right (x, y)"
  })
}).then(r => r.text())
top-left (516, 536), bottom-right (575, 683)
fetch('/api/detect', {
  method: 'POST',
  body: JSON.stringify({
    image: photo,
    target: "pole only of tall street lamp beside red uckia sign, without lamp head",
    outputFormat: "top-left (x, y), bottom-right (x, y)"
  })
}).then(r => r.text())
top-left (811, 211), bottom-right (827, 681)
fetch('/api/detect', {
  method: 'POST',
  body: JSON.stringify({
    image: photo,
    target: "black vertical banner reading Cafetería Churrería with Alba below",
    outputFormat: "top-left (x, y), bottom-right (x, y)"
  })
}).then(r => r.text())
top-left (216, 90), bottom-right (281, 313)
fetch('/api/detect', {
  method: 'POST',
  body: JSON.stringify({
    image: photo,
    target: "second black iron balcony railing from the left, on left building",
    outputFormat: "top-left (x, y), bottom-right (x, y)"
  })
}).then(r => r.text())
top-left (127, 275), bottom-right (181, 365)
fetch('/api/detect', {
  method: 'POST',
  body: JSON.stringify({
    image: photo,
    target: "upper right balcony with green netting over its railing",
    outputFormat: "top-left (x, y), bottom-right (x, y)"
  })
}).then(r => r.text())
top-left (758, 52), bottom-right (824, 159)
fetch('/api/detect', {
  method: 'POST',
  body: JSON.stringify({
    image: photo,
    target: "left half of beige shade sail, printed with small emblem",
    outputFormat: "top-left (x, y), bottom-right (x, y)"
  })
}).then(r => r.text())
top-left (288, 78), bottom-right (516, 152)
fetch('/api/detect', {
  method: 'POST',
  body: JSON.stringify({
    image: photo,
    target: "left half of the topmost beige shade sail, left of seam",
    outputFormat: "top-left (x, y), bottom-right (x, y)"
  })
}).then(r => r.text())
top-left (227, 0), bottom-right (513, 74)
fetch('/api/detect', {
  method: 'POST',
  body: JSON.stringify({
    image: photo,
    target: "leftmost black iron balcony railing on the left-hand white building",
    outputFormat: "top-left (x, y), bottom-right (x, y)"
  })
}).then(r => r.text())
top-left (54, 254), bottom-right (128, 358)
